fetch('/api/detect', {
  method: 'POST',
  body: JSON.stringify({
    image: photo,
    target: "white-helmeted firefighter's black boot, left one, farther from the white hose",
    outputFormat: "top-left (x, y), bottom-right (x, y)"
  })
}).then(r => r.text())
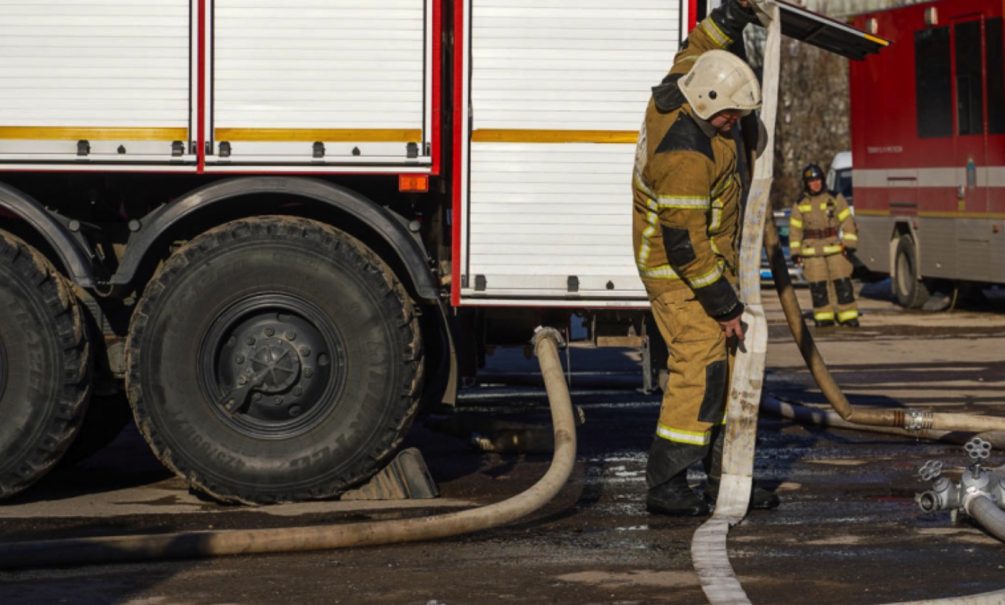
top-left (645, 437), bottom-right (709, 517)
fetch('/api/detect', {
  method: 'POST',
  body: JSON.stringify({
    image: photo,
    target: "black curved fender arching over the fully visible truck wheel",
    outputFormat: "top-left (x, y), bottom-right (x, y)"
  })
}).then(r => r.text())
top-left (112, 176), bottom-right (438, 303)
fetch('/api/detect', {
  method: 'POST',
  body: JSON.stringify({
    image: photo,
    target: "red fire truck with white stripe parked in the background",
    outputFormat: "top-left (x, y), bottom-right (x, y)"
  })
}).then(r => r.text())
top-left (850, 0), bottom-right (1005, 308)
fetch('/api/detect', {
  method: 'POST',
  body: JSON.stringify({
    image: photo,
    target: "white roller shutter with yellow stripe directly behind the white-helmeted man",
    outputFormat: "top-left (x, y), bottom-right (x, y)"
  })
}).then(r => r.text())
top-left (460, 0), bottom-right (686, 306)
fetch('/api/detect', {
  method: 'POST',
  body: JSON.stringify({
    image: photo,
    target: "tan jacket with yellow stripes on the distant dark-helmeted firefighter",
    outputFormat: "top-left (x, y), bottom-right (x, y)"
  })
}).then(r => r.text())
top-left (789, 190), bottom-right (858, 257)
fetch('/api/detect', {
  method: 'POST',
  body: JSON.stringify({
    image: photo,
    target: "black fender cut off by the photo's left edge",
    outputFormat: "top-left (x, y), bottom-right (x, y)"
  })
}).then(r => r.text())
top-left (0, 183), bottom-right (95, 287)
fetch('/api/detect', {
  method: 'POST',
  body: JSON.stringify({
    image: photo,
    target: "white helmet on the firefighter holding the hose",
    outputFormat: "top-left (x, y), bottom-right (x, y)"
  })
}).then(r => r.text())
top-left (677, 50), bottom-right (761, 120)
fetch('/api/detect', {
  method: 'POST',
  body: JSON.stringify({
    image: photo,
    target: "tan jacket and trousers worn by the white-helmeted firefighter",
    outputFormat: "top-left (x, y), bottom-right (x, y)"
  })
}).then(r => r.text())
top-left (632, 39), bottom-right (743, 447)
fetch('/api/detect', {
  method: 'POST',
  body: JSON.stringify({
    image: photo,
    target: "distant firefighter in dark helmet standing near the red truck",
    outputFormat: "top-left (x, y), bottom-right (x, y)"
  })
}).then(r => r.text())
top-left (789, 164), bottom-right (858, 328)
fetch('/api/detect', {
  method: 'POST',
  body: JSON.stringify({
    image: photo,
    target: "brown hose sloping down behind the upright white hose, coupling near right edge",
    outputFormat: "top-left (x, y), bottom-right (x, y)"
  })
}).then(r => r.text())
top-left (764, 220), bottom-right (1005, 433)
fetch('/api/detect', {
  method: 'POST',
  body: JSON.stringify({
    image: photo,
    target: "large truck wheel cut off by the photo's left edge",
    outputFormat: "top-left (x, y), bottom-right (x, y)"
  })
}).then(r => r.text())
top-left (0, 233), bottom-right (90, 497)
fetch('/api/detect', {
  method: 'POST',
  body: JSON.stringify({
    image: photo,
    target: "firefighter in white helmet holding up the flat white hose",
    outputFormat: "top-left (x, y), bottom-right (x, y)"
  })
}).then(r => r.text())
top-left (632, 1), bottom-right (778, 516)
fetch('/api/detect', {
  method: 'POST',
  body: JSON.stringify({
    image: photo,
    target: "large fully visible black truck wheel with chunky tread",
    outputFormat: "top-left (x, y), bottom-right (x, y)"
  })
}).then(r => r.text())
top-left (127, 216), bottom-right (423, 502)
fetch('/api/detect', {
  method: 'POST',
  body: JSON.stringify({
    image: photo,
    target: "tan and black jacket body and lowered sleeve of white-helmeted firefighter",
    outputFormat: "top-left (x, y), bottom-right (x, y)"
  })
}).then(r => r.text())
top-left (632, 100), bottom-right (743, 320)
